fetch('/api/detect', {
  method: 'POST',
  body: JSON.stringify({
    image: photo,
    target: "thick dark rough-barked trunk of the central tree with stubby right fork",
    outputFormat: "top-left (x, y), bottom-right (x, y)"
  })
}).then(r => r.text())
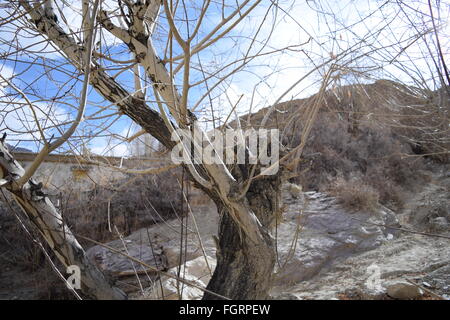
top-left (203, 176), bottom-right (280, 300)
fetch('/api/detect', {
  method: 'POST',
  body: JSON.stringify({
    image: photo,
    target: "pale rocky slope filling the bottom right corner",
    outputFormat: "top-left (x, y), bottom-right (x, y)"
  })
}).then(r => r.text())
top-left (280, 172), bottom-right (450, 300)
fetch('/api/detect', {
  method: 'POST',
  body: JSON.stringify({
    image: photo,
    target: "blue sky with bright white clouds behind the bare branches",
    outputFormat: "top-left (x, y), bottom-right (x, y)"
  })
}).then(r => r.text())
top-left (0, 0), bottom-right (450, 155)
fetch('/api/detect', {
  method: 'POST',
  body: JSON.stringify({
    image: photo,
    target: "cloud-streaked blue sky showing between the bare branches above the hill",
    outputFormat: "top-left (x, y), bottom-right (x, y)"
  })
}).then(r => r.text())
top-left (0, 0), bottom-right (450, 155)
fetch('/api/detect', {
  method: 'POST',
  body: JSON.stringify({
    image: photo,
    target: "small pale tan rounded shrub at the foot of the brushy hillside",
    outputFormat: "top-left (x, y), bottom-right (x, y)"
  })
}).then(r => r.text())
top-left (329, 178), bottom-right (379, 211)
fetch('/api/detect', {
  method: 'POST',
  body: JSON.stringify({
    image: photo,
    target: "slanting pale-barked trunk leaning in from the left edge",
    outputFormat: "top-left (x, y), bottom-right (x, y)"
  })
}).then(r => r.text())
top-left (0, 141), bottom-right (126, 299)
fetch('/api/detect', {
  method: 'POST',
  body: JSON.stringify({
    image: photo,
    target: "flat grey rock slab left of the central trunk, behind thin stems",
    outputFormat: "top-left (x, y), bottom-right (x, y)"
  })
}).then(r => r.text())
top-left (87, 206), bottom-right (218, 275)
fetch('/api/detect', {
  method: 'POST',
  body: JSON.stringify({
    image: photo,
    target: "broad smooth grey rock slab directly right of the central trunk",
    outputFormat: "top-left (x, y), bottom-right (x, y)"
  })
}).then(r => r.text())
top-left (275, 187), bottom-right (399, 285)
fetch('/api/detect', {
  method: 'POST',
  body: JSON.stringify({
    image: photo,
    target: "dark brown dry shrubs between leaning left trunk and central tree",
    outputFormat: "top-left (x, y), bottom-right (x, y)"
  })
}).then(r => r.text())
top-left (61, 170), bottom-right (186, 246)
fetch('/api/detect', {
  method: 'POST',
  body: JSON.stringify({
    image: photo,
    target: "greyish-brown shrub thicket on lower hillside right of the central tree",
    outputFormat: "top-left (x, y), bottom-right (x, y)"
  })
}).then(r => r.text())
top-left (296, 113), bottom-right (424, 209)
